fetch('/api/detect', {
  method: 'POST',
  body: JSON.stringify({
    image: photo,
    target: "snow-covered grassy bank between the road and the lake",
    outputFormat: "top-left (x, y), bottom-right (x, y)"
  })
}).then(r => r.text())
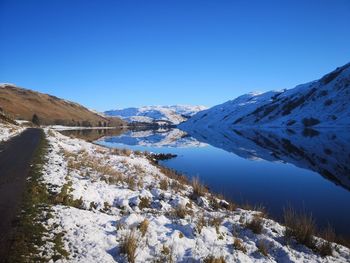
top-left (39, 129), bottom-right (350, 262)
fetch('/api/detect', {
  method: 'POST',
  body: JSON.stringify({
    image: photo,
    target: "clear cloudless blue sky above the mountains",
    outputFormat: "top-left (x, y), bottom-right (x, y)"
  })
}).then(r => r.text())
top-left (0, 0), bottom-right (350, 111)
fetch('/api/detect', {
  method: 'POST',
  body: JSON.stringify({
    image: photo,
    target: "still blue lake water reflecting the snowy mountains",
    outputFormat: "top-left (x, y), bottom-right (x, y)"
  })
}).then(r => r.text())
top-left (60, 129), bottom-right (350, 236)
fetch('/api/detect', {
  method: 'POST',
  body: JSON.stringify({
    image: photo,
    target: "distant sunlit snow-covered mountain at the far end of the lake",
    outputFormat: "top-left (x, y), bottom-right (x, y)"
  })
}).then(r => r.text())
top-left (104, 105), bottom-right (206, 124)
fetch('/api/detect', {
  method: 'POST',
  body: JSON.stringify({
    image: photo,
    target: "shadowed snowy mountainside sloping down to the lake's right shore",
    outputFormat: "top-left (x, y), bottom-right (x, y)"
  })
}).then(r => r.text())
top-left (180, 63), bottom-right (350, 130)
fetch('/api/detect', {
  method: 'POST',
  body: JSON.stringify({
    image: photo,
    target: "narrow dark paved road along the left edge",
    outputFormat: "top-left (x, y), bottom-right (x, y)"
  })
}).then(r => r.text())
top-left (0, 128), bottom-right (42, 261)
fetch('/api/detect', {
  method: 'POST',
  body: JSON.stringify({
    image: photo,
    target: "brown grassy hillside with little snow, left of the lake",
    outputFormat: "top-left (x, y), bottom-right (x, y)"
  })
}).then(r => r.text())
top-left (0, 84), bottom-right (124, 126)
